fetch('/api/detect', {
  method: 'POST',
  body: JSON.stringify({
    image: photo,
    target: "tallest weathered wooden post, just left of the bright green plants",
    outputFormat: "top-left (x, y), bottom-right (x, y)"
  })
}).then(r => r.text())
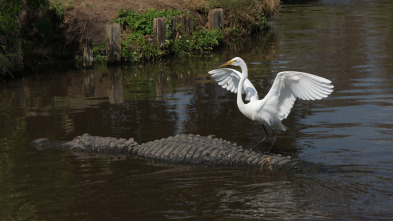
top-left (106, 23), bottom-right (121, 63)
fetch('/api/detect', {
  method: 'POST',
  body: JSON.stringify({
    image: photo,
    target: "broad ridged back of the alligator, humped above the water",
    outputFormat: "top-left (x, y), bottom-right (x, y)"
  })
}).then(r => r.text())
top-left (136, 134), bottom-right (278, 166)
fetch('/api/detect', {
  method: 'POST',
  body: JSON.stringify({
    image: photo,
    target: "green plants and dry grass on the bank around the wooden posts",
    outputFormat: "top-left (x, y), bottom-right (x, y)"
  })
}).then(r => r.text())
top-left (90, 0), bottom-right (278, 62)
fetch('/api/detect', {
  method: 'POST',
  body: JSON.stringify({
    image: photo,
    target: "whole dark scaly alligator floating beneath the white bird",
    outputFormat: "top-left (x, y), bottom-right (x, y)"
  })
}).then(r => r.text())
top-left (31, 134), bottom-right (332, 173)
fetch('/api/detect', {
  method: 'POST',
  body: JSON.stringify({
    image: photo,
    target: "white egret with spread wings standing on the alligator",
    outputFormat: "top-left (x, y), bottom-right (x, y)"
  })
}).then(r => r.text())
top-left (209, 57), bottom-right (334, 152)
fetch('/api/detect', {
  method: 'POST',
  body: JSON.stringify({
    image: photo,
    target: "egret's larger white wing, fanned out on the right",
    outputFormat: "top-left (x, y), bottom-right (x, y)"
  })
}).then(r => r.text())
top-left (263, 71), bottom-right (334, 120)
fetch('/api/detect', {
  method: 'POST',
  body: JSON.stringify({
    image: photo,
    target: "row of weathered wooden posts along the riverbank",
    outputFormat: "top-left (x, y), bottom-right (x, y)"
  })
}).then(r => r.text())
top-left (82, 8), bottom-right (224, 67)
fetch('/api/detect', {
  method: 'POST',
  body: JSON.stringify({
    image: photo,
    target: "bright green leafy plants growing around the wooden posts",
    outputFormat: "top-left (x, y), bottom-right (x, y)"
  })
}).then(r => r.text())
top-left (113, 9), bottom-right (223, 62)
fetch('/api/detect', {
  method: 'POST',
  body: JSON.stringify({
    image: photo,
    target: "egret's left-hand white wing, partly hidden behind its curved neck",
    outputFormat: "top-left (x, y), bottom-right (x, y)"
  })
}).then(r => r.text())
top-left (209, 68), bottom-right (259, 101)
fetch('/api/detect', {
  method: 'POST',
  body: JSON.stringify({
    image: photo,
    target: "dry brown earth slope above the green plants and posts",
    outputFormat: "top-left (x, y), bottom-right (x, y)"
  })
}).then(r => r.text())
top-left (57, 0), bottom-right (280, 43)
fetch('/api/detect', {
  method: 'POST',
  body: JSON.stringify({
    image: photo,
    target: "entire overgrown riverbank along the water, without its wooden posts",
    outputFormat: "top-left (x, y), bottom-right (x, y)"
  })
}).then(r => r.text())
top-left (0, 0), bottom-right (280, 79)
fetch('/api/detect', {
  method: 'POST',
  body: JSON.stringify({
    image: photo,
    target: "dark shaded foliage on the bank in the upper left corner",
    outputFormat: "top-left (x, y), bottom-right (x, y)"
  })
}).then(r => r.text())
top-left (0, 0), bottom-right (64, 79)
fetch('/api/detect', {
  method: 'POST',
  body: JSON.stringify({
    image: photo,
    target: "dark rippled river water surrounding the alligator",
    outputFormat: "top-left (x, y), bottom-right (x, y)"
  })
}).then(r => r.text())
top-left (0, 0), bottom-right (393, 220)
